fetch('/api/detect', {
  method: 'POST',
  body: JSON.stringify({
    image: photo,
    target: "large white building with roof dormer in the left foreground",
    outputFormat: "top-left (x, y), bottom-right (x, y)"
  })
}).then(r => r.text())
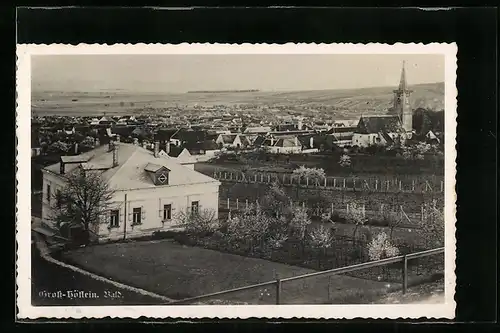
top-left (42, 142), bottom-right (220, 240)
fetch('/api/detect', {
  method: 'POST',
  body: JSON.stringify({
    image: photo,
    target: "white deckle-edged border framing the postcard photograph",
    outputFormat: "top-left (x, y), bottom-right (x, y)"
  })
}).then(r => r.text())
top-left (16, 43), bottom-right (458, 319)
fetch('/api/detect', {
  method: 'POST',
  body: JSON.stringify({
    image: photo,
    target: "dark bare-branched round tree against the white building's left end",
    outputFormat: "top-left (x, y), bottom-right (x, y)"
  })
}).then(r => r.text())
top-left (52, 170), bottom-right (114, 243)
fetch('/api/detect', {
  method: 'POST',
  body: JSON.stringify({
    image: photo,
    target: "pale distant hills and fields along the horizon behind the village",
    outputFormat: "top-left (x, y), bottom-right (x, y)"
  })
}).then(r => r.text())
top-left (32, 83), bottom-right (444, 118)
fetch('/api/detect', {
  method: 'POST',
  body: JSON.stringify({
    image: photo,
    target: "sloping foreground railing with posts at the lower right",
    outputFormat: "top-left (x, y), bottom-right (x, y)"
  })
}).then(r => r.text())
top-left (166, 247), bottom-right (444, 305)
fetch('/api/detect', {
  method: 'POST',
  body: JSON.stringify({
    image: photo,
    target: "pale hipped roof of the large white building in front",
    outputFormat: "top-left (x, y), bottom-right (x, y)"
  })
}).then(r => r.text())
top-left (45, 142), bottom-right (217, 190)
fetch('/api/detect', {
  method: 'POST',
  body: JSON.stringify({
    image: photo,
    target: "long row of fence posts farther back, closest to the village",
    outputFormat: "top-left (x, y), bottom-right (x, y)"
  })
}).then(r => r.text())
top-left (213, 171), bottom-right (444, 193)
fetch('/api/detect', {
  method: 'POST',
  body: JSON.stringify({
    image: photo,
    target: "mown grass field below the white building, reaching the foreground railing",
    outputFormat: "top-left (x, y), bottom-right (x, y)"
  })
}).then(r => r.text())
top-left (63, 240), bottom-right (396, 304)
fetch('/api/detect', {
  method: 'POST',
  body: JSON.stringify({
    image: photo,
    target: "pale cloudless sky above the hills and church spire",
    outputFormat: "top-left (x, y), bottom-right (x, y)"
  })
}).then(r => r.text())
top-left (31, 54), bottom-right (445, 93)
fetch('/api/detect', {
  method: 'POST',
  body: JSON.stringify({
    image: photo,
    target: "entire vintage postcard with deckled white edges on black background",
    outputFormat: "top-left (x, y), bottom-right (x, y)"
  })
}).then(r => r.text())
top-left (16, 43), bottom-right (458, 319)
